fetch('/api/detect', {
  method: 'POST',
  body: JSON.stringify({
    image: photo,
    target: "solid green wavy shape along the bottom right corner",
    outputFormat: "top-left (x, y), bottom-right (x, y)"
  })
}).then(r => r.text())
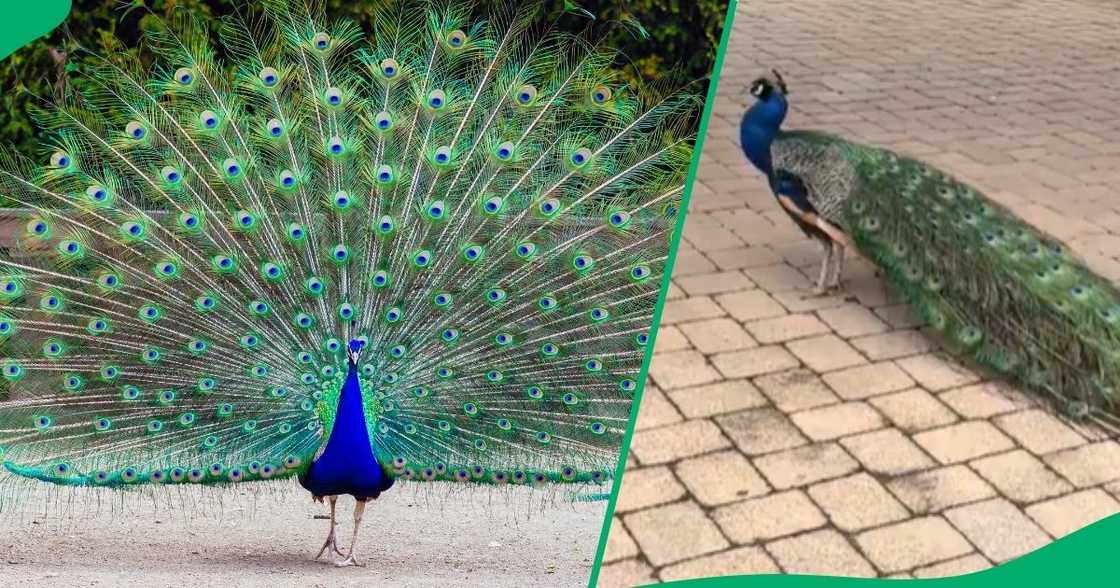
top-left (657, 514), bottom-right (1120, 588)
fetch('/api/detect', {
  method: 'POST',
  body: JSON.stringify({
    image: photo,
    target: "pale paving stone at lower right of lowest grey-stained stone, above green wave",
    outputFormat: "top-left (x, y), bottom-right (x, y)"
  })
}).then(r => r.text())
top-left (945, 498), bottom-right (1049, 563)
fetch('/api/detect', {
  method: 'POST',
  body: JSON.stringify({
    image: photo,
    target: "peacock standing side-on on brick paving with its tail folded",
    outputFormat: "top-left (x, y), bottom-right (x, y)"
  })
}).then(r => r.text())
top-left (740, 71), bottom-right (1120, 431)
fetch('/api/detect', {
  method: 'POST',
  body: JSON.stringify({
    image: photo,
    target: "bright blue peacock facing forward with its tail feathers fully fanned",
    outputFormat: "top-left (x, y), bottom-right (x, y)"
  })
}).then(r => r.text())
top-left (0, 0), bottom-right (701, 566)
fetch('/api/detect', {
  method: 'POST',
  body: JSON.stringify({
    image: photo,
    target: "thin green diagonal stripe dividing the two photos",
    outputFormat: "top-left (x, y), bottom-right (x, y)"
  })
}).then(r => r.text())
top-left (587, 0), bottom-right (739, 588)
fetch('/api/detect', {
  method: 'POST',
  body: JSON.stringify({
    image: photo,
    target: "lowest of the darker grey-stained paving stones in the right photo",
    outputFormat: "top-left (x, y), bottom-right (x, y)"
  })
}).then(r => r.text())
top-left (887, 465), bottom-right (996, 514)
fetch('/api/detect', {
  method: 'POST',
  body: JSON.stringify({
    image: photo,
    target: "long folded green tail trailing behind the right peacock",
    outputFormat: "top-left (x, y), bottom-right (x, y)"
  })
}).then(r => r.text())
top-left (841, 143), bottom-right (1120, 431)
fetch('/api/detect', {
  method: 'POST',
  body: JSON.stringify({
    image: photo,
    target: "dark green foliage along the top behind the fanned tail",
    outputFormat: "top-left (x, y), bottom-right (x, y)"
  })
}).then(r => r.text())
top-left (0, 0), bottom-right (728, 155)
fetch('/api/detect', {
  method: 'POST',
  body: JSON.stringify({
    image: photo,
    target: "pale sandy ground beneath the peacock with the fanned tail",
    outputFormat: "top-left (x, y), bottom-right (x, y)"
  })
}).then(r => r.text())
top-left (0, 482), bottom-right (606, 587)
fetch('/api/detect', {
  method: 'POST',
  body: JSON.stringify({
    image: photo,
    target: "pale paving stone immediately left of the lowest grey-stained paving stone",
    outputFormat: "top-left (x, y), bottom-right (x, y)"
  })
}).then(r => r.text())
top-left (809, 472), bottom-right (909, 532)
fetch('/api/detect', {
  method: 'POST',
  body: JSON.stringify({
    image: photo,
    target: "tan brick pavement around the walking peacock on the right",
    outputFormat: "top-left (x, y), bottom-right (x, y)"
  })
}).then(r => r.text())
top-left (600, 0), bottom-right (1120, 586)
